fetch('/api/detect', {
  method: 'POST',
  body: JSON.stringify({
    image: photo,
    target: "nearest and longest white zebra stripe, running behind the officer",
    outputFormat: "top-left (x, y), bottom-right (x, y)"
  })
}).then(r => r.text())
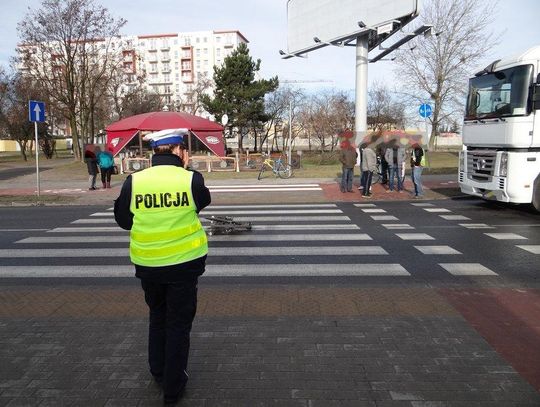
top-left (0, 263), bottom-right (410, 279)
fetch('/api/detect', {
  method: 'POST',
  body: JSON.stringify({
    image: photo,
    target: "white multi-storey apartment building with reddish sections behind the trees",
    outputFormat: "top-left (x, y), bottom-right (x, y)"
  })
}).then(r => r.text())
top-left (18, 30), bottom-right (249, 124)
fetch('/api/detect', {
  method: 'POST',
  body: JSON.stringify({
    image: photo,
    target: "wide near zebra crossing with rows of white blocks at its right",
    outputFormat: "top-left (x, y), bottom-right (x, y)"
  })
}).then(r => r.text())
top-left (0, 202), bottom-right (540, 278)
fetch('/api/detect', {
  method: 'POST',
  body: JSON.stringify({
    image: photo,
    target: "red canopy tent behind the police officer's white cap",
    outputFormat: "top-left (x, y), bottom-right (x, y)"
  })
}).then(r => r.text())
top-left (105, 112), bottom-right (225, 157)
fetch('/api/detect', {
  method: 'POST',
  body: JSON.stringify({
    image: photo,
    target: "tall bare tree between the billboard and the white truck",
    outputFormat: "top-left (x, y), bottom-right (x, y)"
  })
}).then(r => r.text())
top-left (396, 0), bottom-right (498, 147)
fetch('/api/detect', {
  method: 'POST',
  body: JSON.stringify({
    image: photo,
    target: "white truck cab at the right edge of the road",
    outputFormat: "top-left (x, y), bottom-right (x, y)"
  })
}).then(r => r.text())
top-left (459, 46), bottom-right (540, 211)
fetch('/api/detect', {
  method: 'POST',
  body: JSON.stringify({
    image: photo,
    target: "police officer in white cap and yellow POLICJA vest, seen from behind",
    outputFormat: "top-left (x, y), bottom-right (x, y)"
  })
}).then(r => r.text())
top-left (114, 129), bottom-right (211, 405)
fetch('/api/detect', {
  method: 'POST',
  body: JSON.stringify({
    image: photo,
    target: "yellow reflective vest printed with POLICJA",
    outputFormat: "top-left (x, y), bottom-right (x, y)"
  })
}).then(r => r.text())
top-left (129, 165), bottom-right (208, 267)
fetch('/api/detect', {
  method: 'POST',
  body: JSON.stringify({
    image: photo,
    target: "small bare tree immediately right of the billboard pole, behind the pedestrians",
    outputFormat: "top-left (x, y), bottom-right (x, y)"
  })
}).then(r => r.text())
top-left (367, 82), bottom-right (405, 132)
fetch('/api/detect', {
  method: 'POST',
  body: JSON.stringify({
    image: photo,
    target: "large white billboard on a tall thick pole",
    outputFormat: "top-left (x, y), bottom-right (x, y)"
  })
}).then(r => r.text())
top-left (279, 0), bottom-right (431, 143)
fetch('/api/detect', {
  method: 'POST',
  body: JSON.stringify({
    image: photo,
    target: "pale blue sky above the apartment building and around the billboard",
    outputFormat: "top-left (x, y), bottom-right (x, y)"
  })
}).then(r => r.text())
top-left (0, 0), bottom-right (540, 94)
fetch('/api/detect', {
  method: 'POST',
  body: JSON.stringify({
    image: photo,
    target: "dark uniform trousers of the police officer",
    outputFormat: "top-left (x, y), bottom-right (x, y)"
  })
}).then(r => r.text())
top-left (141, 276), bottom-right (198, 397)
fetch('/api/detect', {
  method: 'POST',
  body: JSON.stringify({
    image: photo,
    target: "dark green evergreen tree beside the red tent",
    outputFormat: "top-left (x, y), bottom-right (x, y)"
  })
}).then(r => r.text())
top-left (202, 43), bottom-right (279, 151)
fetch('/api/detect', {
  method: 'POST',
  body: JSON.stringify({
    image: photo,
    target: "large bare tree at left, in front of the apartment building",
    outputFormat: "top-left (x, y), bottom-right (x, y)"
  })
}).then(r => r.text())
top-left (18, 0), bottom-right (125, 159)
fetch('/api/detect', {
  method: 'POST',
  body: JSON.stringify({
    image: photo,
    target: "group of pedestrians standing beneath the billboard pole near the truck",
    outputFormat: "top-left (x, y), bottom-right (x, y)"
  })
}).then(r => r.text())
top-left (339, 139), bottom-right (425, 198)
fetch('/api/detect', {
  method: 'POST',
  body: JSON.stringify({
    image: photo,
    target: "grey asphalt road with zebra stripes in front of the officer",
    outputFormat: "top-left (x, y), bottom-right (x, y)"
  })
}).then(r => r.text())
top-left (0, 199), bottom-right (540, 284)
